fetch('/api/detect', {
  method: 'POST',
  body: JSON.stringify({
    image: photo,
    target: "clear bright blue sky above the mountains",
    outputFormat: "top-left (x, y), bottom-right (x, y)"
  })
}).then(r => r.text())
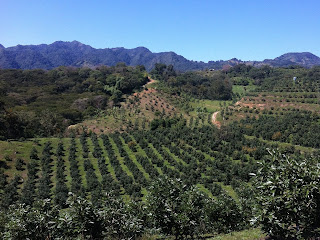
top-left (0, 0), bottom-right (320, 62)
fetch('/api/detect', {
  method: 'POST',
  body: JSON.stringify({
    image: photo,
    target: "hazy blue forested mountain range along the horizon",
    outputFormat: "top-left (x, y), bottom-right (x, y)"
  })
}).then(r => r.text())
top-left (0, 41), bottom-right (320, 71)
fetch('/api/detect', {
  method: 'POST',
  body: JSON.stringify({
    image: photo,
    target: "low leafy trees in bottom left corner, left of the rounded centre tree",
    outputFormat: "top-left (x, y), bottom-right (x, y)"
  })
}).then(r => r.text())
top-left (0, 194), bottom-right (145, 240)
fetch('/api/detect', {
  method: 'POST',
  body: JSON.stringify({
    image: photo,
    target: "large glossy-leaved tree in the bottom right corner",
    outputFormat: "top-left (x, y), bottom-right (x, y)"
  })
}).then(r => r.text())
top-left (254, 151), bottom-right (320, 239)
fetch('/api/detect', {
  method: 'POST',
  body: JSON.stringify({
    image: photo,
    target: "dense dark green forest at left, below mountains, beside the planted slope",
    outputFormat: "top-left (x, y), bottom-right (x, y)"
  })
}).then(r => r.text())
top-left (0, 65), bottom-right (148, 139)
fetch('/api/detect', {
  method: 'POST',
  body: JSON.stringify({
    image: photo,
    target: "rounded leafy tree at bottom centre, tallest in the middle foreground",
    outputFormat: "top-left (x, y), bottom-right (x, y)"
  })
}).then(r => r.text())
top-left (147, 177), bottom-right (207, 239)
